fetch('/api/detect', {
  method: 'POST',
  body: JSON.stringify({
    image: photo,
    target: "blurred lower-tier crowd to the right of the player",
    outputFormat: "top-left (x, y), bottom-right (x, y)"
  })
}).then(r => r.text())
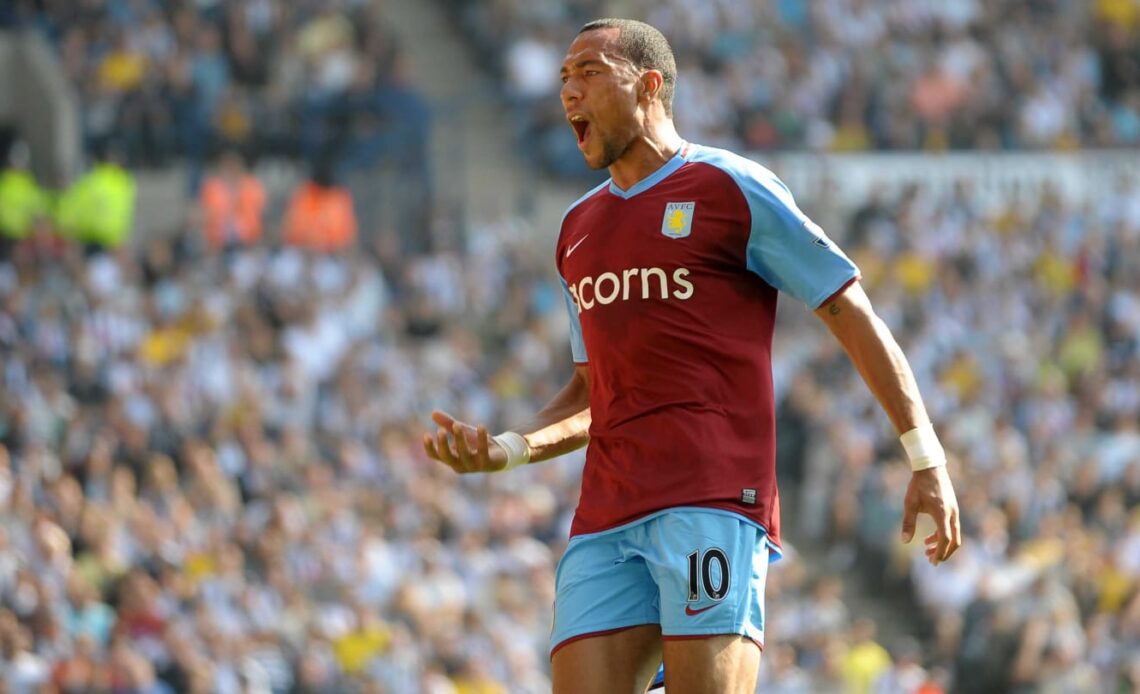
top-left (781, 177), bottom-right (1140, 692)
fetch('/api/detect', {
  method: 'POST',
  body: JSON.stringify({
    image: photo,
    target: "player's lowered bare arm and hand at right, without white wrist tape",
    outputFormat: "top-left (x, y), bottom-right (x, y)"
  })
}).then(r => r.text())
top-left (815, 281), bottom-right (962, 564)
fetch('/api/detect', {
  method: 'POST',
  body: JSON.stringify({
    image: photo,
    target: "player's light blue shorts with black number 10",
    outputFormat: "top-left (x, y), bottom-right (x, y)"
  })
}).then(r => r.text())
top-left (551, 507), bottom-right (770, 655)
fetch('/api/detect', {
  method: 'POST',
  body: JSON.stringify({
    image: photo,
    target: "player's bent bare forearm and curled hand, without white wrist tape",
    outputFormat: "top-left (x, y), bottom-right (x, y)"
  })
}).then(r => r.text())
top-left (423, 365), bottom-right (589, 473)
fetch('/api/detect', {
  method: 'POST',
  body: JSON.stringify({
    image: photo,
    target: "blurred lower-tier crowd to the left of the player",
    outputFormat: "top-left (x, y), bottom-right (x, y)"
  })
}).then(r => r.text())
top-left (0, 190), bottom-right (884, 693)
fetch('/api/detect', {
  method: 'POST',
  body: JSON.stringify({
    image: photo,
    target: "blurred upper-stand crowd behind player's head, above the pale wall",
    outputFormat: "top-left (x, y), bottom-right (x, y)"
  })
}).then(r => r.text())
top-left (450, 0), bottom-right (1140, 173)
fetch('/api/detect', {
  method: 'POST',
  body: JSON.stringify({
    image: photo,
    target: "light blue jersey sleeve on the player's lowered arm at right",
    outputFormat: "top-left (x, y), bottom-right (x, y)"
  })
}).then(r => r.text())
top-left (735, 165), bottom-right (860, 310)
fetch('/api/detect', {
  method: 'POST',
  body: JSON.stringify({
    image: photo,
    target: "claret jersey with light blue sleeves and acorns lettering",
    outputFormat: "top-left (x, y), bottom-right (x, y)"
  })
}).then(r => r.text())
top-left (556, 145), bottom-right (858, 550)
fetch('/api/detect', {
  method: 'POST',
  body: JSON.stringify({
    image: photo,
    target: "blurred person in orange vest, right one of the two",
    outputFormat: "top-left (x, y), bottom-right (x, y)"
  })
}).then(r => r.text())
top-left (282, 158), bottom-right (357, 253)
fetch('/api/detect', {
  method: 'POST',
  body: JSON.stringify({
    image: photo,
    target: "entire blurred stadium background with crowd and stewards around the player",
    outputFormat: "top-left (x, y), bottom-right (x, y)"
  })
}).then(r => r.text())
top-left (0, 0), bottom-right (1140, 694)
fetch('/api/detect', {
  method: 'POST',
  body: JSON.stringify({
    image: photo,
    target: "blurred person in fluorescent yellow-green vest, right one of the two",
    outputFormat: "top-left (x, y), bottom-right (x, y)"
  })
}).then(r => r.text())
top-left (56, 144), bottom-right (135, 248)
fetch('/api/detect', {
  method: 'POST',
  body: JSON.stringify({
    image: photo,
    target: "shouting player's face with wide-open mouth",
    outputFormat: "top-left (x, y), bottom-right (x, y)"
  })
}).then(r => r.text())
top-left (561, 28), bottom-right (641, 169)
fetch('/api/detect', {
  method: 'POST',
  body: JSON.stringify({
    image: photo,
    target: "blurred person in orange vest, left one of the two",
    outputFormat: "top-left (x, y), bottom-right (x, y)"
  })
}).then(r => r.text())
top-left (200, 150), bottom-right (266, 251)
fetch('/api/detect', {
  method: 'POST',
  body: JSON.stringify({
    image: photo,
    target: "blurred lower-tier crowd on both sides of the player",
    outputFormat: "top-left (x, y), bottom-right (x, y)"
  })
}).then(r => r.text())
top-left (0, 153), bottom-right (1140, 692)
